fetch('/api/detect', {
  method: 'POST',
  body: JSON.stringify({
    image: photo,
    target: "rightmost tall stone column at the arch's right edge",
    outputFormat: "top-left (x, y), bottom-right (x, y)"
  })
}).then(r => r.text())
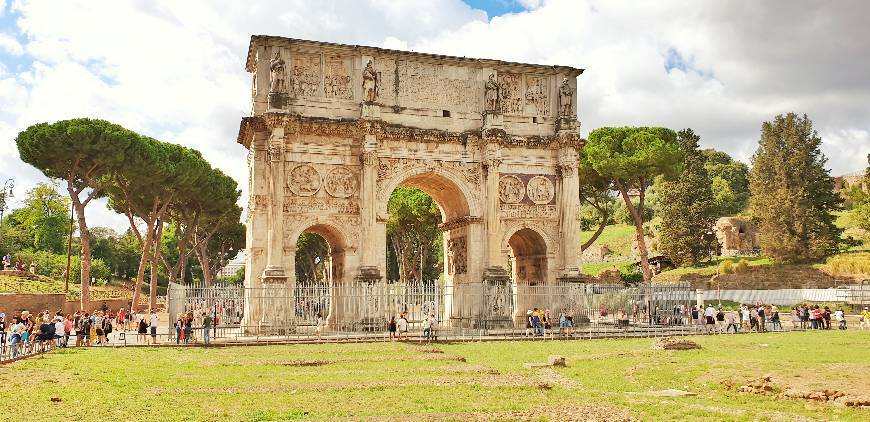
top-left (559, 146), bottom-right (580, 277)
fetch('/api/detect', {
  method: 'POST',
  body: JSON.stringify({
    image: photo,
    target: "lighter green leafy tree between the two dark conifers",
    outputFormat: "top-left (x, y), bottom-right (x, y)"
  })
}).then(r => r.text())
top-left (702, 149), bottom-right (749, 217)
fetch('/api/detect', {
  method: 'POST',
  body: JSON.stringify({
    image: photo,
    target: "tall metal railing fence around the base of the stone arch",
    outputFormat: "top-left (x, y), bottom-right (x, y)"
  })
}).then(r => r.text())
top-left (166, 282), bottom-right (695, 340)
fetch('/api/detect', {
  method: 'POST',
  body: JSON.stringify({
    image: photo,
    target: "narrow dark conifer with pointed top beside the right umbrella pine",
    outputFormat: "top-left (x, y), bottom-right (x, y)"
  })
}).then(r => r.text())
top-left (656, 129), bottom-right (717, 266)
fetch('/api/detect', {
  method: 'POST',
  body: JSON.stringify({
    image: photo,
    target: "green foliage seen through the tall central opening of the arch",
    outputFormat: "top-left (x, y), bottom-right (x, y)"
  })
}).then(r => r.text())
top-left (387, 187), bottom-right (444, 281)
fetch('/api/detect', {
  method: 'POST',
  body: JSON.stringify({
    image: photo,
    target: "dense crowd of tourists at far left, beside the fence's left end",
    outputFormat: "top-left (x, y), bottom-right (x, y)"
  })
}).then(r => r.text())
top-left (0, 309), bottom-right (159, 359)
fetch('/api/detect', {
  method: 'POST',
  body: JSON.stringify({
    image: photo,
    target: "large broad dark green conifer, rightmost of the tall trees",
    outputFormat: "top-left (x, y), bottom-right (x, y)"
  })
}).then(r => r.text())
top-left (750, 113), bottom-right (842, 262)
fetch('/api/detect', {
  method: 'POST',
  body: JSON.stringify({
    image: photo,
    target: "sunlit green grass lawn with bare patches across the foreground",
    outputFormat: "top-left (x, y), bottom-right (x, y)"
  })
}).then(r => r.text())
top-left (0, 331), bottom-right (870, 421)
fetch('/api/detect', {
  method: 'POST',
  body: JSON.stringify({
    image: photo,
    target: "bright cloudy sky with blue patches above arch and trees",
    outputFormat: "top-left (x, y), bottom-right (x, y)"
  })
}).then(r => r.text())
top-left (0, 0), bottom-right (870, 231)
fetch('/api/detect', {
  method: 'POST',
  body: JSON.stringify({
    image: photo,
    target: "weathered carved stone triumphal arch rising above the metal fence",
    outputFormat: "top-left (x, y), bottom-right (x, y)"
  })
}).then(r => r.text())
top-left (238, 36), bottom-right (583, 326)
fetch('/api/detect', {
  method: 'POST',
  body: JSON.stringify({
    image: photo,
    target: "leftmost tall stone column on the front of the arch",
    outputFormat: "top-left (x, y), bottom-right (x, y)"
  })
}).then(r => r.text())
top-left (260, 127), bottom-right (287, 284)
